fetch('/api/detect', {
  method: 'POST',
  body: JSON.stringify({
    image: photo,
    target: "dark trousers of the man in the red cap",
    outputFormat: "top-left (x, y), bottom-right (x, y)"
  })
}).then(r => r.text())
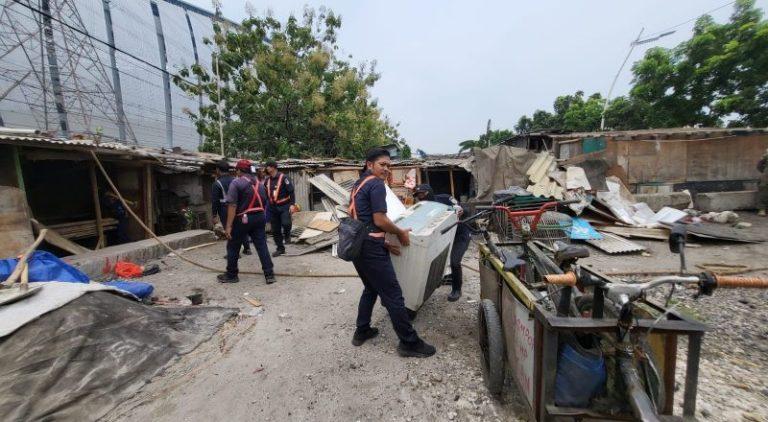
top-left (227, 212), bottom-right (274, 277)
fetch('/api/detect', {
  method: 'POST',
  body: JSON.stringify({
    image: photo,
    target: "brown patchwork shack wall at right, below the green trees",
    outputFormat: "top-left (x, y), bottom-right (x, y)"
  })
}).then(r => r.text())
top-left (558, 134), bottom-right (768, 188)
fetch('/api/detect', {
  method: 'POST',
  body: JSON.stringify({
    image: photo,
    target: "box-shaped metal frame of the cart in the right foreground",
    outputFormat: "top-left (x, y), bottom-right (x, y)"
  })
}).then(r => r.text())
top-left (479, 245), bottom-right (708, 421)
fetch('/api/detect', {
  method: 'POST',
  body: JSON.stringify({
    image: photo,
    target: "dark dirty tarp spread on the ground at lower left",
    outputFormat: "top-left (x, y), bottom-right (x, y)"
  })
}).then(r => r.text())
top-left (0, 292), bottom-right (235, 421)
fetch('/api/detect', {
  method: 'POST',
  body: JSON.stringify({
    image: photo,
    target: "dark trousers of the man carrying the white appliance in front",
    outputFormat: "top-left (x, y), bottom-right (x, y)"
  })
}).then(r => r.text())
top-left (352, 238), bottom-right (419, 343)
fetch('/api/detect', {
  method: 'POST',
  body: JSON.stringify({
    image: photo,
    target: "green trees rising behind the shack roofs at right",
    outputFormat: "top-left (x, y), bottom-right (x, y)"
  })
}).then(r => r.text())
top-left (515, 0), bottom-right (768, 133)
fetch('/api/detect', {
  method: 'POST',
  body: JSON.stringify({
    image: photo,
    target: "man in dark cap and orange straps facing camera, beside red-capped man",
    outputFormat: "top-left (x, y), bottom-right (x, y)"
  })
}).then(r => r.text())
top-left (264, 161), bottom-right (296, 256)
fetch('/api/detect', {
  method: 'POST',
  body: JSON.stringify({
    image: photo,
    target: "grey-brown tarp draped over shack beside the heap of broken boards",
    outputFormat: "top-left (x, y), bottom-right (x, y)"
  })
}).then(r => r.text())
top-left (472, 145), bottom-right (536, 201)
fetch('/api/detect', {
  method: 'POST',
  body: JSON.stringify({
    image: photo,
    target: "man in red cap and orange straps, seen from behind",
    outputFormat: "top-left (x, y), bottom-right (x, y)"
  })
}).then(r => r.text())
top-left (217, 160), bottom-right (276, 284)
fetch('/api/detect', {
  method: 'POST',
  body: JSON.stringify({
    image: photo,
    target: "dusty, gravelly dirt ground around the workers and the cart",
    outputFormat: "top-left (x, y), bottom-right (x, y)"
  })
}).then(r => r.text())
top-left (105, 215), bottom-right (768, 421)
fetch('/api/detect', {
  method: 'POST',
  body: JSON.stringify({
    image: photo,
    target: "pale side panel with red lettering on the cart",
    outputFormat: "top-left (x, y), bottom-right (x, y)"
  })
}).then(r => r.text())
top-left (502, 289), bottom-right (536, 407)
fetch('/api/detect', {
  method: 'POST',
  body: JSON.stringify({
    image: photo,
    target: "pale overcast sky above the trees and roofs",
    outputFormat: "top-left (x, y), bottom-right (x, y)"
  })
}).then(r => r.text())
top-left (187, 0), bottom-right (768, 153)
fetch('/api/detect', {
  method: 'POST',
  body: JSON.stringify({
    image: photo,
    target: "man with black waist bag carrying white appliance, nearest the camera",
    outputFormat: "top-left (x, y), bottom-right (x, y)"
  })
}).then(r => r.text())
top-left (350, 148), bottom-right (435, 357)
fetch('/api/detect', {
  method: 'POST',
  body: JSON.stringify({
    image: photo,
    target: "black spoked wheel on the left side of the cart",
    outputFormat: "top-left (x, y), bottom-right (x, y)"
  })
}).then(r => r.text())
top-left (477, 299), bottom-right (504, 394)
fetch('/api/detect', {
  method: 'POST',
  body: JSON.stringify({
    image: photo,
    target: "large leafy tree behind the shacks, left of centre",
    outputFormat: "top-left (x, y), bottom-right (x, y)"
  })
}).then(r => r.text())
top-left (174, 9), bottom-right (407, 158)
